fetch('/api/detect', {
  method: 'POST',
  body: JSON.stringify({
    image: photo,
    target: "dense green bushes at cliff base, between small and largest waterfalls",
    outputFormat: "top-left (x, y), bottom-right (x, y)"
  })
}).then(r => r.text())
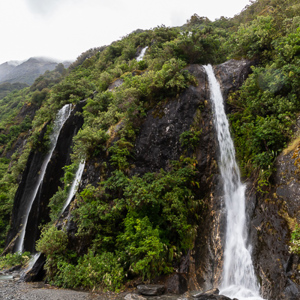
top-left (37, 158), bottom-right (203, 290)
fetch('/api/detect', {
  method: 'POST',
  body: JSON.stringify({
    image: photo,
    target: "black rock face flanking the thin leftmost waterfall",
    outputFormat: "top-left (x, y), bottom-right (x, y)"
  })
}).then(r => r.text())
top-left (7, 102), bottom-right (85, 252)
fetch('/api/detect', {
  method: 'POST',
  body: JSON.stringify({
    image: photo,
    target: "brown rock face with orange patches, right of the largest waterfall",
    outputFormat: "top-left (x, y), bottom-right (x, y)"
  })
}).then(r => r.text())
top-left (252, 149), bottom-right (300, 300)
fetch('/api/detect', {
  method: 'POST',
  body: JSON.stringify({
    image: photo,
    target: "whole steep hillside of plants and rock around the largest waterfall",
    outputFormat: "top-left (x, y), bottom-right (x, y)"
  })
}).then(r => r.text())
top-left (0, 0), bottom-right (300, 299)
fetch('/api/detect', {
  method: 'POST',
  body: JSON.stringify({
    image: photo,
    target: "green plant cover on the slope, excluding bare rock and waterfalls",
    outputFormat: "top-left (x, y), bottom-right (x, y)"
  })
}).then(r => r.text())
top-left (0, 0), bottom-right (300, 296)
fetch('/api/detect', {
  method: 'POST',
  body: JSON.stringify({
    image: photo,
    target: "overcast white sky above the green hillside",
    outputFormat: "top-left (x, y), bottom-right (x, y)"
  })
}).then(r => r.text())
top-left (0, 0), bottom-right (250, 64)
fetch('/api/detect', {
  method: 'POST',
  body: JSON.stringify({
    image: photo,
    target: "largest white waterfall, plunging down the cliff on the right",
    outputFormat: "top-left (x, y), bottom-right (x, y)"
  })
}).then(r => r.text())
top-left (204, 65), bottom-right (262, 300)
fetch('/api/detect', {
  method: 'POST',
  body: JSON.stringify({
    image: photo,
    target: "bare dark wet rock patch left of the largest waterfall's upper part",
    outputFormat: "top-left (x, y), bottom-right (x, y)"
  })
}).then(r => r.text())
top-left (133, 65), bottom-right (210, 174)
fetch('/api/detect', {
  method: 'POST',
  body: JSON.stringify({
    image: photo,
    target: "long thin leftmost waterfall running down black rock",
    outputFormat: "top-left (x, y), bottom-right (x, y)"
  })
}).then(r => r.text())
top-left (16, 104), bottom-right (72, 252)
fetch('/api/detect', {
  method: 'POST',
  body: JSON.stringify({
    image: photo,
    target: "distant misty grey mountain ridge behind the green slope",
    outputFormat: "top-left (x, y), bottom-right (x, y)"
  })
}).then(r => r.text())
top-left (0, 57), bottom-right (72, 85)
